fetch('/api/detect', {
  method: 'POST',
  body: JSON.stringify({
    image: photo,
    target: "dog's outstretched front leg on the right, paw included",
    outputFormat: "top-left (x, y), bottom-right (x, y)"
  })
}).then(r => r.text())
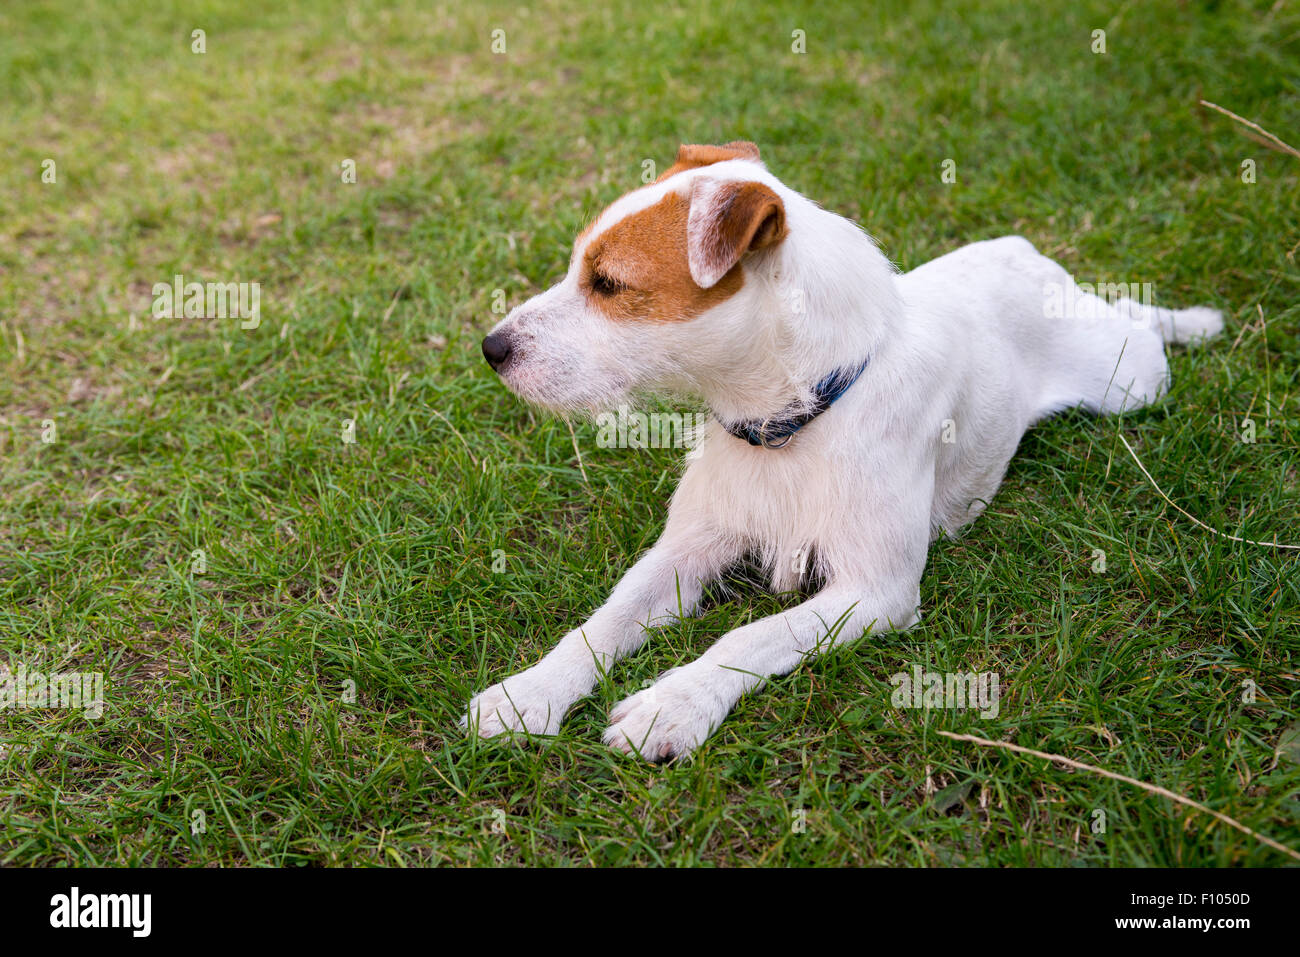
top-left (605, 573), bottom-right (919, 761)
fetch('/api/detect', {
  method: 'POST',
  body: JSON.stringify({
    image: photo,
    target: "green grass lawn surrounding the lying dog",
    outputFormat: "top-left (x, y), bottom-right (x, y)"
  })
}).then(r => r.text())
top-left (0, 0), bottom-right (1300, 866)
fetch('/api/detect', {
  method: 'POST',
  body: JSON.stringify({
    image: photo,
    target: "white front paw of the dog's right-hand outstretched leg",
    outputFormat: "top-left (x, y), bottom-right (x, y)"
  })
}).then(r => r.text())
top-left (605, 671), bottom-right (727, 762)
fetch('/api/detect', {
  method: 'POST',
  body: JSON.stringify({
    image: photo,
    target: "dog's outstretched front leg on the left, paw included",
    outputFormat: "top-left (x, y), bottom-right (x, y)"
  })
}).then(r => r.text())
top-left (460, 518), bottom-right (735, 737)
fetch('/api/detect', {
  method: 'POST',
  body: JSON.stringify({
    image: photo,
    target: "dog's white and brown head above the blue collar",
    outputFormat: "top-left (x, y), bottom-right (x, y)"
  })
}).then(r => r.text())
top-left (482, 142), bottom-right (892, 411)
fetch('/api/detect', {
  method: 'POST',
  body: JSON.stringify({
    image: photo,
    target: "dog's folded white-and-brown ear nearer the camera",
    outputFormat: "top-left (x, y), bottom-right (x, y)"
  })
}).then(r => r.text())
top-left (686, 178), bottom-right (788, 289)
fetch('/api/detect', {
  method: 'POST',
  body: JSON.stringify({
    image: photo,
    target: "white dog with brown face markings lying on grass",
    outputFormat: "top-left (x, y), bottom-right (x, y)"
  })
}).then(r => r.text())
top-left (462, 142), bottom-right (1223, 762)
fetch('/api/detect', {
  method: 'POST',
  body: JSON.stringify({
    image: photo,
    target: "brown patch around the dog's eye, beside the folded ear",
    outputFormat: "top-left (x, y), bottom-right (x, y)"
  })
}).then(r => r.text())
top-left (579, 192), bottom-right (745, 322)
